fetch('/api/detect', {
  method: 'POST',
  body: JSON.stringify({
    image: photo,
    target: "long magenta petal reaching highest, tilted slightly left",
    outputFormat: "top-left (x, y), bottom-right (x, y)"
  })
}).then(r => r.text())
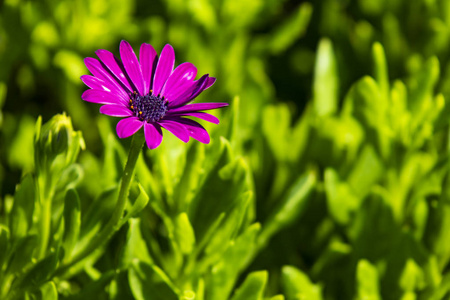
top-left (120, 40), bottom-right (145, 96)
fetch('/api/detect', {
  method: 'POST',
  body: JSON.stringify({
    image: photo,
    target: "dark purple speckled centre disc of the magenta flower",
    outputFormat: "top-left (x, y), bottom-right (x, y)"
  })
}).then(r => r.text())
top-left (130, 91), bottom-right (169, 122)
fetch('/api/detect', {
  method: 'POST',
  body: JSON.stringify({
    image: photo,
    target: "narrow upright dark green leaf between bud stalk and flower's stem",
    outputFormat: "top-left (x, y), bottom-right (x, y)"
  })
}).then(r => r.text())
top-left (63, 189), bottom-right (81, 261)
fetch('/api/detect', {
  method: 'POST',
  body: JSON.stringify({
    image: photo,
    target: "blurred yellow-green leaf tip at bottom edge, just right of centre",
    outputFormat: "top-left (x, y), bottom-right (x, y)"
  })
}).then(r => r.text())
top-left (281, 266), bottom-right (323, 300)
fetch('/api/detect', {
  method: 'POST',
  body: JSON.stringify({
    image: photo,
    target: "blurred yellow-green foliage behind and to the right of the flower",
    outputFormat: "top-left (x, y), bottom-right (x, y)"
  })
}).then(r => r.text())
top-left (0, 0), bottom-right (450, 300)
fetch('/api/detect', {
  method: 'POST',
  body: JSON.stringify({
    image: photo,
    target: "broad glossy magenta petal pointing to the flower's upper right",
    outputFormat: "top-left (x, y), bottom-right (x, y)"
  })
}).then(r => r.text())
top-left (161, 62), bottom-right (197, 101)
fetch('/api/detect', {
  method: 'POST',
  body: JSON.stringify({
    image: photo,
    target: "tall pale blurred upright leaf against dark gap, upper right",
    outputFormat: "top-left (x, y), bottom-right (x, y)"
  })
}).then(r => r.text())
top-left (314, 39), bottom-right (339, 116)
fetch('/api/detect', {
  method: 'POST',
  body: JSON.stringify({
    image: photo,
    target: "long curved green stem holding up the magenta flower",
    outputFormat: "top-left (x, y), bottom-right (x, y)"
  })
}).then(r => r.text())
top-left (57, 132), bottom-right (145, 275)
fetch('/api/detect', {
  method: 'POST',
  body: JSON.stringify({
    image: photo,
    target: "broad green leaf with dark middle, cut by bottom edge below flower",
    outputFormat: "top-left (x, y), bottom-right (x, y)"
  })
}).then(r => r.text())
top-left (128, 262), bottom-right (178, 300)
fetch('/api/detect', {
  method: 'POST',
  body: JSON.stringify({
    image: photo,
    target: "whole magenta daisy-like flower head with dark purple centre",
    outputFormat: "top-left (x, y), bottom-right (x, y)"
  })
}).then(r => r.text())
top-left (81, 41), bottom-right (228, 149)
